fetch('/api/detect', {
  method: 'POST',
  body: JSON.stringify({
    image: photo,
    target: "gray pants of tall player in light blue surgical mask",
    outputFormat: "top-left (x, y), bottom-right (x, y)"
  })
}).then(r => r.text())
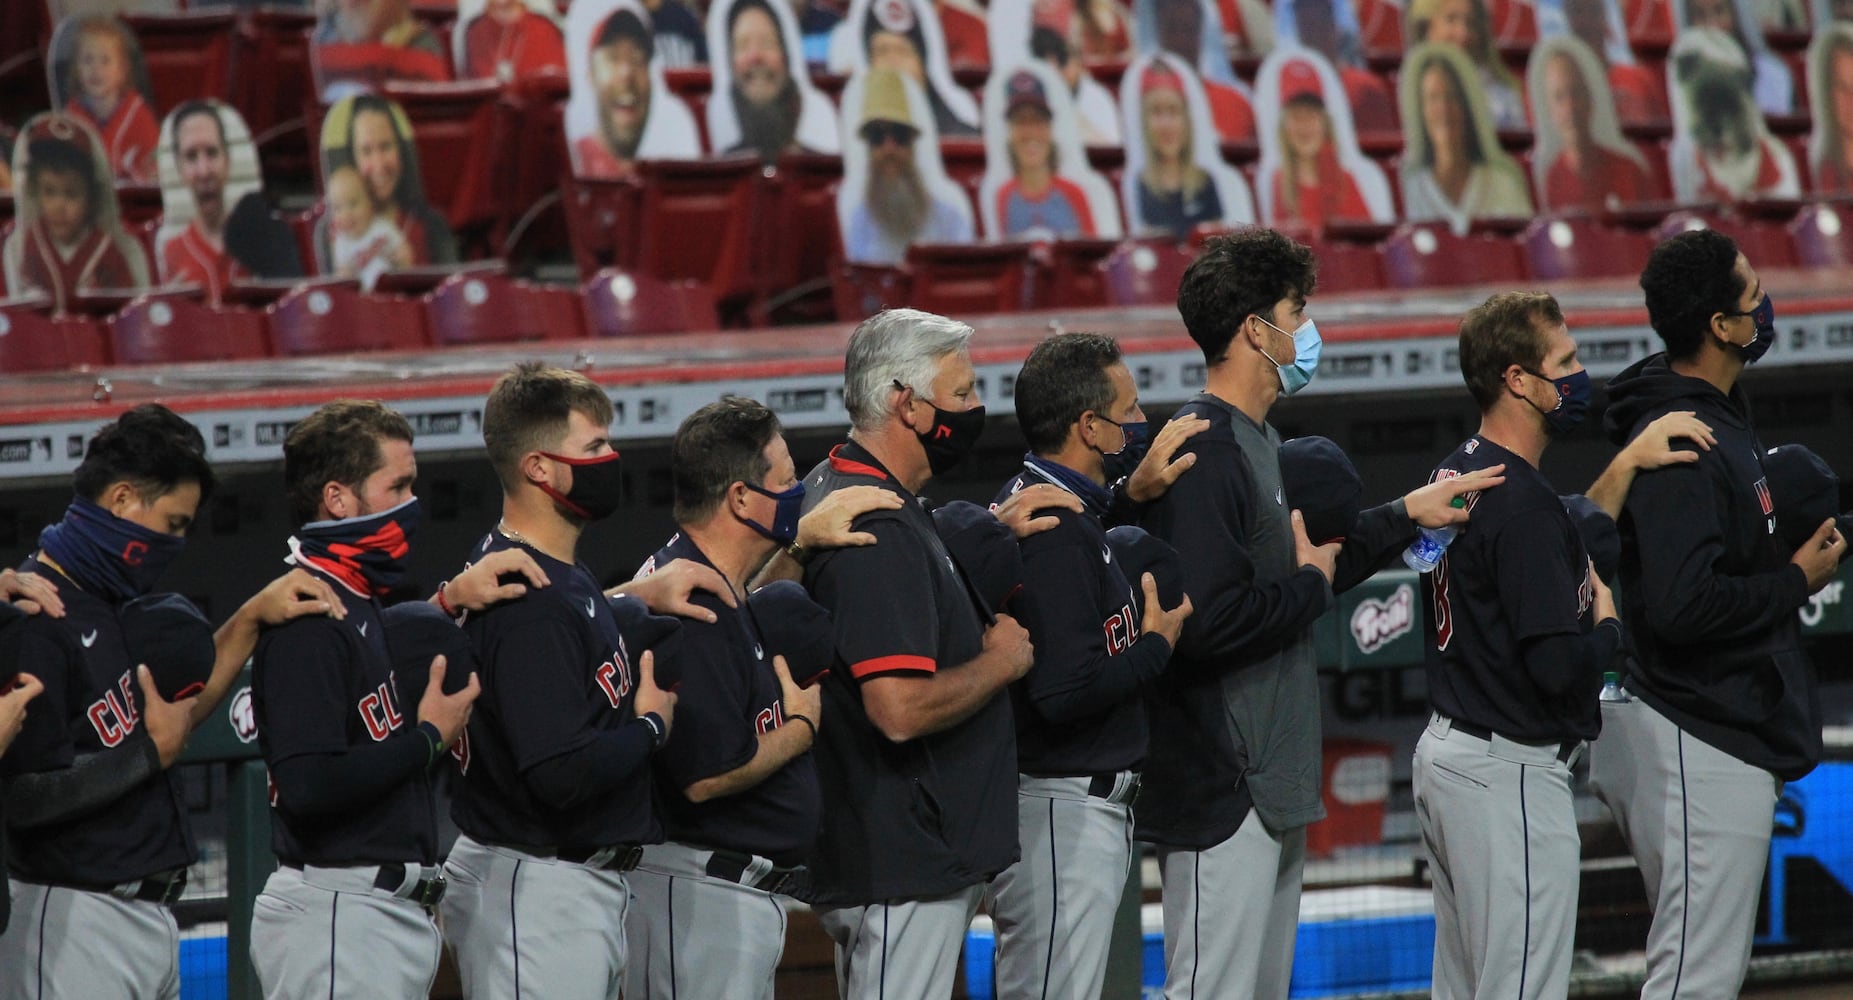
top-left (1158, 809), bottom-right (1306, 1000)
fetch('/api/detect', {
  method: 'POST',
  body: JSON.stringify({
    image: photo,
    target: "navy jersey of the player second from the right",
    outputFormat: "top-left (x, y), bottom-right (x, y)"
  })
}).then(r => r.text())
top-left (1425, 437), bottom-right (1607, 743)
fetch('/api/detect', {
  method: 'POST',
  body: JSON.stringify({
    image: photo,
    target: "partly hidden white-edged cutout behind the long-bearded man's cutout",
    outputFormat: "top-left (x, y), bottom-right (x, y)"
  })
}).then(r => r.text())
top-left (830, 0), bottom-right (978, 137)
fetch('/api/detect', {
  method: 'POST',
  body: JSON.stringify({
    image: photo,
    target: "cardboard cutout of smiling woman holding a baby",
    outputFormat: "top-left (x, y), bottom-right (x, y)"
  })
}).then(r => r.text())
top-left (315, 94), bottom-right (458, 276)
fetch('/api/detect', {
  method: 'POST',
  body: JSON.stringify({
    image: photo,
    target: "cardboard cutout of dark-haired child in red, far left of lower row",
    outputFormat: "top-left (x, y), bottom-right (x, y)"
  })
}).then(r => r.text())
top-left (0, 111), bottom-right (148, 311)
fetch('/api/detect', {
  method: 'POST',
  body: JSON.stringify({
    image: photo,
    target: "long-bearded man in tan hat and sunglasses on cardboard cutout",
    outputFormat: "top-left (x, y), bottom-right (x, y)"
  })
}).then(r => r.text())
top-left (843, 69), bottom-right (973, 265)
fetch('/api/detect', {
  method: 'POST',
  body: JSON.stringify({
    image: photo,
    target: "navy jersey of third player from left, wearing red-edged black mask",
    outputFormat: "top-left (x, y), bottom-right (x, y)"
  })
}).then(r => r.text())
top-left (450, 531), bottom-right (663, 850)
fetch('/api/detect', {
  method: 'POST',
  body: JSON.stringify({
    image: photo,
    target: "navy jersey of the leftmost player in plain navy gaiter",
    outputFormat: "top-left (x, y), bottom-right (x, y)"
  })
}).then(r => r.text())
top-left (0, 559), bottom-right (195, 887)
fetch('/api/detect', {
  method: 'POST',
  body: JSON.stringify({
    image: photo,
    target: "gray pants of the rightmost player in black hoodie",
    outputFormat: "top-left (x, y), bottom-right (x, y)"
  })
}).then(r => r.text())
top-left (1590, 698), bottom-right (1783, 1000)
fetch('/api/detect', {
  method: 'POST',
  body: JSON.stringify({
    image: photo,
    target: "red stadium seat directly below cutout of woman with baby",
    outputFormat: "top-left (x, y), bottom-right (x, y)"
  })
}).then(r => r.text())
top-left (271, 281), bottom-right (430, 356)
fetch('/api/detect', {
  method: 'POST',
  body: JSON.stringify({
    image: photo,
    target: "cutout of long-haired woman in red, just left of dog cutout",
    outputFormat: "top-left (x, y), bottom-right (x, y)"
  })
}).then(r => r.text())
top-left (1525, 35), bottom-right (1653, 213)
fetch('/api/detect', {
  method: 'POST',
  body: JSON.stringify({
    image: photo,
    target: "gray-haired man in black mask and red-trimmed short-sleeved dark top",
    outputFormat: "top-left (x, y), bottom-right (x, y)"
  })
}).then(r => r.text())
top-left (804, 309), bottom-right (1078, 1000)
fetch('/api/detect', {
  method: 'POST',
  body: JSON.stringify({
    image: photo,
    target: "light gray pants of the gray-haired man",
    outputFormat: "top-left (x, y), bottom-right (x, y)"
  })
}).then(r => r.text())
top-left (817, 883), bottom-right (984, 1000)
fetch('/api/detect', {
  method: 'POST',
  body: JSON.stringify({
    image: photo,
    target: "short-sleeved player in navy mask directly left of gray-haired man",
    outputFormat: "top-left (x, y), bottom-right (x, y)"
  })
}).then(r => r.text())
top-left (624, 396), bottom-right (901, 1000)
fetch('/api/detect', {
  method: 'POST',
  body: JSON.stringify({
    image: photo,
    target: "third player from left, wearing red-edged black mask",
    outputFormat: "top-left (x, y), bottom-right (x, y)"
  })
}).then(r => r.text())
top-left (441, 365), bottom-right (676, 1000)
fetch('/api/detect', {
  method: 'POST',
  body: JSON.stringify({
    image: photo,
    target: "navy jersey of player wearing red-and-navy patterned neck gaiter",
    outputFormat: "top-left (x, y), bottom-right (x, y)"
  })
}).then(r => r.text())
top-left (250, 581), bottom-right (437, 865)
